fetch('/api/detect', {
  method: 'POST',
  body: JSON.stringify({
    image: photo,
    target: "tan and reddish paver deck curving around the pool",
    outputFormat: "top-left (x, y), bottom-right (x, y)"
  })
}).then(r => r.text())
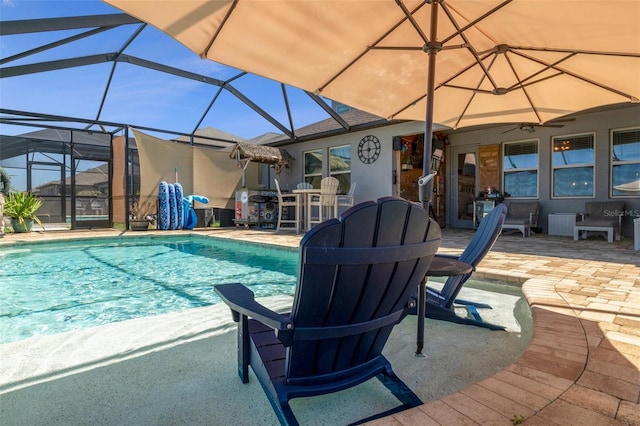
top-left (0, 229), bottom-right (640, 425)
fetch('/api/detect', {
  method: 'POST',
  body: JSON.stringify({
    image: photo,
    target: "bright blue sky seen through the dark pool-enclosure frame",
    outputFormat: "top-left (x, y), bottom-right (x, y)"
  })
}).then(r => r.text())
top-left (0, 0), bottom-right (328, 139)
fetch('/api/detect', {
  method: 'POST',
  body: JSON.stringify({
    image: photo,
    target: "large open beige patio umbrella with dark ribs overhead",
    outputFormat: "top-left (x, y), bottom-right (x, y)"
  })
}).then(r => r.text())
top-left (104, 0), bottom-right (640, 195)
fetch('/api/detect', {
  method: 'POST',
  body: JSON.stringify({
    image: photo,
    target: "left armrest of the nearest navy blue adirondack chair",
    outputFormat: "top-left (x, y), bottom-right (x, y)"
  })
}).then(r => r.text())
top-left (213, 284), bottom-right (293, 330)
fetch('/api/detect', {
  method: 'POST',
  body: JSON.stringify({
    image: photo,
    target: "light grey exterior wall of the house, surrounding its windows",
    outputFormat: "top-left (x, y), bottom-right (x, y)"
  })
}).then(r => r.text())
top-left (270, 105), bottom-right (640, 237)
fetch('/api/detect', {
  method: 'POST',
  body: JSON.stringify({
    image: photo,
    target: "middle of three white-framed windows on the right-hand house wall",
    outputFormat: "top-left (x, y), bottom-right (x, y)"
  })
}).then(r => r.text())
top-left (551, 133), bottom-right (595, 198)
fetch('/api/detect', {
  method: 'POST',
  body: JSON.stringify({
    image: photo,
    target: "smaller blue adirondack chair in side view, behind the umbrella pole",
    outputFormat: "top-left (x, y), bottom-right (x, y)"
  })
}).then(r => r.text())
top-left (425, 204), bottom-right (507, 330)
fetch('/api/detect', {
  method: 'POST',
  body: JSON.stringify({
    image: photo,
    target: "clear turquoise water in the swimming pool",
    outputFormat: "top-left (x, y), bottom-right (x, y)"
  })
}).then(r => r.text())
top-left (0, 236), bottom-right (298, 344)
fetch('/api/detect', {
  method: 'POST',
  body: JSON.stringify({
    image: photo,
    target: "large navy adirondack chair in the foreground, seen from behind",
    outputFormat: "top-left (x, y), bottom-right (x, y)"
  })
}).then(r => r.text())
top-left (214, 197), bottom-right (441, 425)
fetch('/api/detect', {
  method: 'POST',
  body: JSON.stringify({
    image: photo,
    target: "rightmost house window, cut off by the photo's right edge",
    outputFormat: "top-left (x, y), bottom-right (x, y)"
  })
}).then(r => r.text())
top-left (611, 128), bottom-right (640, 198)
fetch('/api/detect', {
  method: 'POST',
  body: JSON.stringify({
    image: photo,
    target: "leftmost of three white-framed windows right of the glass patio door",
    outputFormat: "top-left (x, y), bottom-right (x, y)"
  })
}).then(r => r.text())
top-left (502, 140), bottom-right (538, 198)
